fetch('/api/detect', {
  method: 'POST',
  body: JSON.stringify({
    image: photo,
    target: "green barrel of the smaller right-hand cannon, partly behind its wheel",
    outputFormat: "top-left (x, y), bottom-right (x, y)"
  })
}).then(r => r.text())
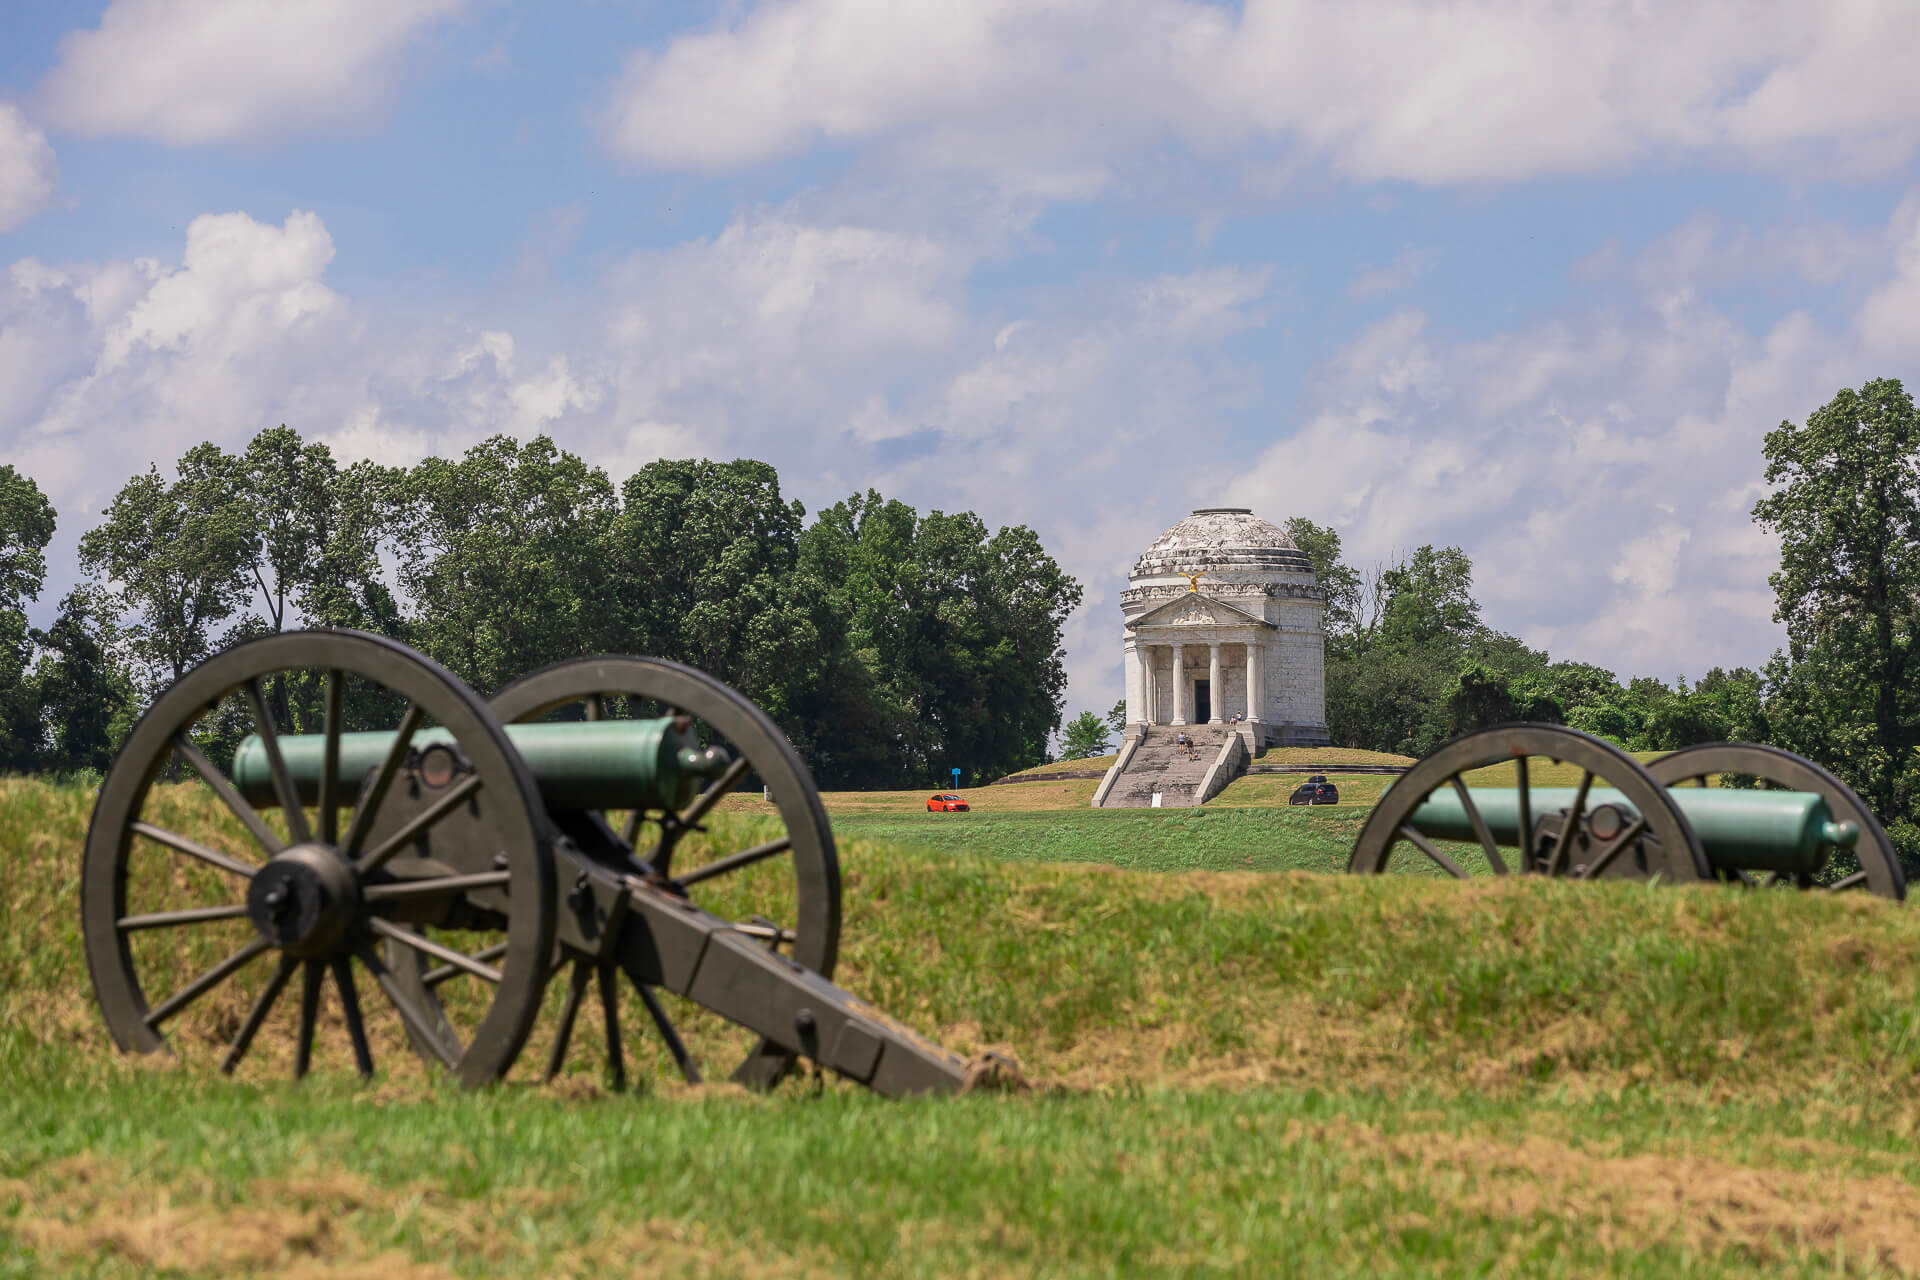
top-left (1413, 787), bottom-right (1859, 873)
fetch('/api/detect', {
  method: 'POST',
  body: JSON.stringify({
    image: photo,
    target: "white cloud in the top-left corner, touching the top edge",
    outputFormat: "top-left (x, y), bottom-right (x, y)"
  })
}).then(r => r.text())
top-left (40, 0), bottom-right (463, 146)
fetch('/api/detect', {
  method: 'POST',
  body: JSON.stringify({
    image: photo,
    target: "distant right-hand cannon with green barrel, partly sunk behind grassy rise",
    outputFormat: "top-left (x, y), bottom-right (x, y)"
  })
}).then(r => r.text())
top-left (1348, 723), bottom-right (1907, 900)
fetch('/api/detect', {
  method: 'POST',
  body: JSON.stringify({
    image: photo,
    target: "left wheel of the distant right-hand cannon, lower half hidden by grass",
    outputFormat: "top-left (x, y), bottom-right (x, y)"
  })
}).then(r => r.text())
top-left (1346, 723), bottom-right (1711, 881)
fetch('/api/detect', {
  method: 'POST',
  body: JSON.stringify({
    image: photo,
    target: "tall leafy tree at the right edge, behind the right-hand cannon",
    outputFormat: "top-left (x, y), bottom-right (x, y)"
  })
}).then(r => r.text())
top-left (1753, 378), bottom-right (1920, 865)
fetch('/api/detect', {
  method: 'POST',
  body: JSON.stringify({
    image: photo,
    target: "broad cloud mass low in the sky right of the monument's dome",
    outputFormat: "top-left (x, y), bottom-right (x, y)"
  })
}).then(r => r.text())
top-left (1231, 200), bottom-right (1920, 677)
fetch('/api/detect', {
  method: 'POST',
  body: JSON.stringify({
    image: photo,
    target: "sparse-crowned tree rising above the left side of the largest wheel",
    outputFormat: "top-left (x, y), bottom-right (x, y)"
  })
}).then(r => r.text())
top-left (81, 443), bottom-right (255, 687)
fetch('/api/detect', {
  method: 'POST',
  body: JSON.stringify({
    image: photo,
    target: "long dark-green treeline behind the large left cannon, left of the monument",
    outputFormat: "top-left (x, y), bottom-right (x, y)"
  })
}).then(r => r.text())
top-left (0, 426), bottom-right (1081, 787)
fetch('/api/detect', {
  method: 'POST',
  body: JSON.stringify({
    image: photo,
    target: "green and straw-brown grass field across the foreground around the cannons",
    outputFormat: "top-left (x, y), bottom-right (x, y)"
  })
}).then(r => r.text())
top-left (0, 781), bottom-right (1920, 1276)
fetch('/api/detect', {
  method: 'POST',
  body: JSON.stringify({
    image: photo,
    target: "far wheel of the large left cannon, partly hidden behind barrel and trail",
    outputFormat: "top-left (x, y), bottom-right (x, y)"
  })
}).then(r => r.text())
top-left (493, 656), bottom-right (841, 1088)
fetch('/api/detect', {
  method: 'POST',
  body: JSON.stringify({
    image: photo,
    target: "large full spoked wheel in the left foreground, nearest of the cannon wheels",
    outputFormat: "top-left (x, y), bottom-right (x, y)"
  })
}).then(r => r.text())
top-left (81, 631), bottom-right (553, 1084)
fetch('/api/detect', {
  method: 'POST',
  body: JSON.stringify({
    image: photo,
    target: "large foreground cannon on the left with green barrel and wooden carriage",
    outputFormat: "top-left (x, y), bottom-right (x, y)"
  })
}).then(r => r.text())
top-left (81, 629), bottom-right (983, 1096)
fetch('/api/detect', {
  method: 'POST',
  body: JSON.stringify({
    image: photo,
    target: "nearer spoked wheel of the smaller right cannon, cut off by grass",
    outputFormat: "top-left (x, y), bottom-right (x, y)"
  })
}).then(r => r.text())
top-left (1346, 723), bottom-right (1711, 881)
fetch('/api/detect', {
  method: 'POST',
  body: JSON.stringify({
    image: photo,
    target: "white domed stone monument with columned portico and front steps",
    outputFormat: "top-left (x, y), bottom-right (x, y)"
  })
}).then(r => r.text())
top-left (1092, 507), bottom-right (1331, 808)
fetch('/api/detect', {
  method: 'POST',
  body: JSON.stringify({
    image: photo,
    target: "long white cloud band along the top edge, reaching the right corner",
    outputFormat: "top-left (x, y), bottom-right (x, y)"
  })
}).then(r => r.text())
top-left (603, 0), bottom-right (1920, 194)
